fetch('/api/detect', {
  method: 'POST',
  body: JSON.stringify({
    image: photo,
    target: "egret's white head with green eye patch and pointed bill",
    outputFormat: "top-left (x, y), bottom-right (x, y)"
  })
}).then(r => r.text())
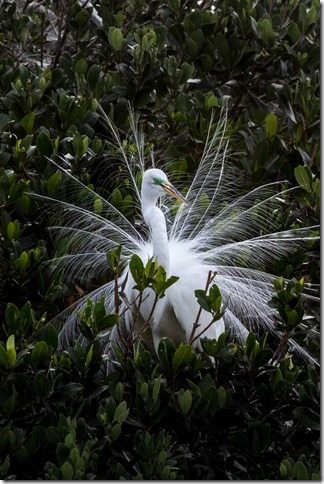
top-left (142, 168), bottom-right (188, 205)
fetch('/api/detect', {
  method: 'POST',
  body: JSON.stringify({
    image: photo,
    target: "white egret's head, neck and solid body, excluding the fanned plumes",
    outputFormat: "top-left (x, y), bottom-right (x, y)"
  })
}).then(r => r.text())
top-left (125, 168), bottom-right (225, 352)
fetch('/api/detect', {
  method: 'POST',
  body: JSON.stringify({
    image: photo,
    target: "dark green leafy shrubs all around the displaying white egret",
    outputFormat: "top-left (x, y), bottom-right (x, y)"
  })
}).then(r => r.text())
top-left (0, 0), bottom-right (320, 480)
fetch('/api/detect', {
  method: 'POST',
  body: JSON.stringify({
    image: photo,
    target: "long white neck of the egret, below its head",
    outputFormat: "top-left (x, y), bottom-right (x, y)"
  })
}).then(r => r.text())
top-left (142, 197), bottom-right (170, 272)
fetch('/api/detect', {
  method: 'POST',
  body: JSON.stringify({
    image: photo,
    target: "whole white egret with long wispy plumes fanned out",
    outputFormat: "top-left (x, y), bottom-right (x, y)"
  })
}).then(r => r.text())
top-left (43, 111), bottom-right (314, 364)
